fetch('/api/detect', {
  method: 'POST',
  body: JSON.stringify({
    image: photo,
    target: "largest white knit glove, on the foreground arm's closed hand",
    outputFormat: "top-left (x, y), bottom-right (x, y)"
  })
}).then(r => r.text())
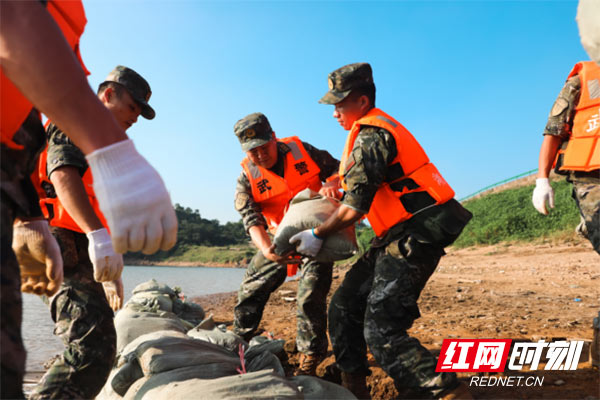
top-left (86, 140), bottom-right (177, 255)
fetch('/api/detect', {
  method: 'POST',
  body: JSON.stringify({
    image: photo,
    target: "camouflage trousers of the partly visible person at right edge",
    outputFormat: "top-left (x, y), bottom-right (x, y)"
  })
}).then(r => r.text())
top-left (573, 179), bottom-right (600, 254)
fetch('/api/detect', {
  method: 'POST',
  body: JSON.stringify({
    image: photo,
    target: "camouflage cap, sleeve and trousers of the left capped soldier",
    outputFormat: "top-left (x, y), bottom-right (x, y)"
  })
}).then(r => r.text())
top-left (31, 65), bottom-right (155, 399)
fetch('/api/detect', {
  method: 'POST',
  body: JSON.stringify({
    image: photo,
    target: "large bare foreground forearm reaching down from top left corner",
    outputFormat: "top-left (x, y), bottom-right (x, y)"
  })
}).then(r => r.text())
top-left (0, 1), bottom-right (127, 154)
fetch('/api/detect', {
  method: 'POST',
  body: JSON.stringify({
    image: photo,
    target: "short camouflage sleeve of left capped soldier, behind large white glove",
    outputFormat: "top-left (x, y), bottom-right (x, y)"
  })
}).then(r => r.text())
top-left (46, 124), bottom-right (88, 177)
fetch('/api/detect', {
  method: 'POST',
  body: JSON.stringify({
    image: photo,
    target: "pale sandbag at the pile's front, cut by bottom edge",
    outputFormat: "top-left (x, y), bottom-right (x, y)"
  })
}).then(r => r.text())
top-left (137, 371), bottom-right (303, 400)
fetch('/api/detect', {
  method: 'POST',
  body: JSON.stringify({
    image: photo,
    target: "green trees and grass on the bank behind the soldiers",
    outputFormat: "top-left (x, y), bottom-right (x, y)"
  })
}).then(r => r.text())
top-left (126, 179), bottom-right (579, 264)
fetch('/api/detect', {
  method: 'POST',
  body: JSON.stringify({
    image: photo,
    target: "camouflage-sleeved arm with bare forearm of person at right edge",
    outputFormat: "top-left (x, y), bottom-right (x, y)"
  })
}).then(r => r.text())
top-left (537, 75), bottom-right (581, 178)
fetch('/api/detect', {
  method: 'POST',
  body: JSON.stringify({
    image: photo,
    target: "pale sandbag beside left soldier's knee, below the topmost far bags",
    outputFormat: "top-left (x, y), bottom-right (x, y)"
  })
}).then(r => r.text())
top-left (115, 308), bottom-right (189, 352)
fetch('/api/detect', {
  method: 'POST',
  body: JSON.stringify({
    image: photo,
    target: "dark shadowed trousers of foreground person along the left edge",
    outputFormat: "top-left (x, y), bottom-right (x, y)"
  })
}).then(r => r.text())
top-left (0, 194), bottom-right (25, 399)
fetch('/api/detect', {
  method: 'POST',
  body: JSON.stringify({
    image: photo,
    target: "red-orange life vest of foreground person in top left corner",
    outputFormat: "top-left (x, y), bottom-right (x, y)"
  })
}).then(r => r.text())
top-left (0, 0), bottom-right (89, 149)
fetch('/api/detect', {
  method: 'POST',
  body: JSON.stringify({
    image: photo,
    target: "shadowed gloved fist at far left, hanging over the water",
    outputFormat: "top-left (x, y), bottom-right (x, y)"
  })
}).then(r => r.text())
top-left (12, 220), bottom-right (64, 296)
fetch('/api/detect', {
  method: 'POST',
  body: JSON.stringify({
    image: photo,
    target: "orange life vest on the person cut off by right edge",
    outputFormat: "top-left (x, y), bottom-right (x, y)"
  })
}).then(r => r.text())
top-left (560, 61), bottom-right (600, 172)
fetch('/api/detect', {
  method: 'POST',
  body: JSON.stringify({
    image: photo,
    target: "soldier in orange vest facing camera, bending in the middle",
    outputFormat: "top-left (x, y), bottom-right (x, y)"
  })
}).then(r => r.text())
top-left (233, 113), bottom-right (339, 375)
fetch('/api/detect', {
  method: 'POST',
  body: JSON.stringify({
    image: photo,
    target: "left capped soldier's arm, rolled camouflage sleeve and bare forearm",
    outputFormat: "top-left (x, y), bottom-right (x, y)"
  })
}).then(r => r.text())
top-left (46, 124), bottom-right (103, 233)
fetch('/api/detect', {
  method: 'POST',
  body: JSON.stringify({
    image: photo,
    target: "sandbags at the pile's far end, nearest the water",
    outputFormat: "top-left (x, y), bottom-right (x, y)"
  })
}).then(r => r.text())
top-left (115, 279), bottom-right (204, 352)
